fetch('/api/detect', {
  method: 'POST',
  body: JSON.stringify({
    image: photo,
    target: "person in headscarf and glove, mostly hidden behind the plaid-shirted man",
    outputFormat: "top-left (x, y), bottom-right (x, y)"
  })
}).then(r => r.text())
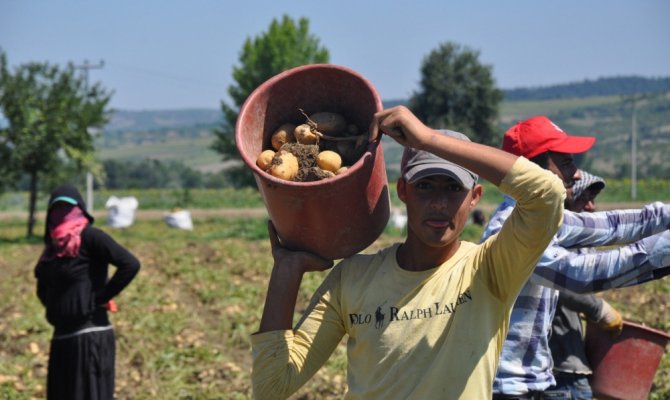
top-left (545, 170), bottom-right (623, 400)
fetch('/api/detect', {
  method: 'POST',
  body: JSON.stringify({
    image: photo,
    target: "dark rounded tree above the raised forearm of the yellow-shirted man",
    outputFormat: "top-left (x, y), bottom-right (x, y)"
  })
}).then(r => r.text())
top-left (409, 42), bottom-right (502, 145)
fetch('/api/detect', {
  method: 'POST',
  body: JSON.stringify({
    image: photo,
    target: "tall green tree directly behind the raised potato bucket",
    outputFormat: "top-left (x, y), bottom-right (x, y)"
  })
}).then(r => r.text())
top-left (212, 15), bottom-right (329, 186)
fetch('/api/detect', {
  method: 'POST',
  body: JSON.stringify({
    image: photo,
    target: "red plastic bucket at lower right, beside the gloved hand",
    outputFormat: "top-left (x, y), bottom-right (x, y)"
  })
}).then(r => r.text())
top-left (585, 321), bottom-right (670, 400)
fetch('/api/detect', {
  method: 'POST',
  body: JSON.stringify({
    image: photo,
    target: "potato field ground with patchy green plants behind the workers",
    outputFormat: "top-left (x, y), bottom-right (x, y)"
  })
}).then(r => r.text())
top-left (0, 218), bottom-right (670, 400)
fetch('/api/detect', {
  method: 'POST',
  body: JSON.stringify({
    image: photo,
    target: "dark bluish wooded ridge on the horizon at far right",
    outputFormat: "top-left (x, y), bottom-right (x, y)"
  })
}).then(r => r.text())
top-left (504, 76), bottom-right (670, 101)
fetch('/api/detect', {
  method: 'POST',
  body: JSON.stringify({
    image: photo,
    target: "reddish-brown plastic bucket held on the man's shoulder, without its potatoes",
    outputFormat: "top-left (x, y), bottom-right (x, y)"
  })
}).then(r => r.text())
top-left (235, 64), bottom-right (390, 259)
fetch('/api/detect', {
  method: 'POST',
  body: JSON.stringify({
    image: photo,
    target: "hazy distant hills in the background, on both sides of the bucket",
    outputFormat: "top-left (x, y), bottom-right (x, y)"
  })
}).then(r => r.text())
top-left (96, 77), bottom-right (670, 178)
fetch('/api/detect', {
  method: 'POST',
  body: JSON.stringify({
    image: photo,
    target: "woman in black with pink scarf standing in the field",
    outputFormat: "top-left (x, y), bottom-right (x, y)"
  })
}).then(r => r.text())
top-left (35, 185), bottom-right (140, 400)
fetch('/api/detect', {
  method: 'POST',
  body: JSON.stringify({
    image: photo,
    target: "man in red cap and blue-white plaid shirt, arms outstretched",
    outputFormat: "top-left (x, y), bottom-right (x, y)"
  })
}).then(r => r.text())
top-left (482, 116), bottom-right (670, 400)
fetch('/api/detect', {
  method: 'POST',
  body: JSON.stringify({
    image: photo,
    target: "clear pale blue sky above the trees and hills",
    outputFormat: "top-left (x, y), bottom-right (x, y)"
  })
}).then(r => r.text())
top-left (0, 0), bottom-right (670, 111)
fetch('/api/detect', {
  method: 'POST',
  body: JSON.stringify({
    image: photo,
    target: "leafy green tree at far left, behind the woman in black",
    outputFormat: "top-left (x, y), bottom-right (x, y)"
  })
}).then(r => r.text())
top-left (0, 52), bottom-right (111, 236)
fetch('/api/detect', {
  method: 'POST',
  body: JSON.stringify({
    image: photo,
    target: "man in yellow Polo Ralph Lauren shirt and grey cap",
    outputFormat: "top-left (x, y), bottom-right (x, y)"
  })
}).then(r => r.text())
top-left (251, 106), bottom-right (565, 400)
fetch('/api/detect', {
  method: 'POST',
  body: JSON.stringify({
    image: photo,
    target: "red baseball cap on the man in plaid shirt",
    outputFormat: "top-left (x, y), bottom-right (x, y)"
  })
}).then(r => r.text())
top-left (503, 116), bottom-right (596, 159)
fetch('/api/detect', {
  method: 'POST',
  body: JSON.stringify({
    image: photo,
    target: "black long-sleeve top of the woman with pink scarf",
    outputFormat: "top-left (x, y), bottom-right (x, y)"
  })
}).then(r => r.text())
top-left (35, 225), bottom-right (140, 334)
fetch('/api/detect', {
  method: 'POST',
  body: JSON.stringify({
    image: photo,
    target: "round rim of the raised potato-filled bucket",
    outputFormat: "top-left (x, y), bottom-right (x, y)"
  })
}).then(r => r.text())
top-left (234, 63), bottom-right (383, 187)
